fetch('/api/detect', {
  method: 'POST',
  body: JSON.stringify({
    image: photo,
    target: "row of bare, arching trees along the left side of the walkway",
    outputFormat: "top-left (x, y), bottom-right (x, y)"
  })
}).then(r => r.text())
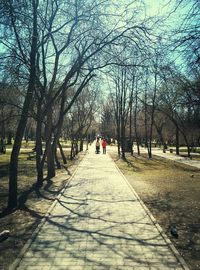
top-left (0, 0), bottom-right (152, 209)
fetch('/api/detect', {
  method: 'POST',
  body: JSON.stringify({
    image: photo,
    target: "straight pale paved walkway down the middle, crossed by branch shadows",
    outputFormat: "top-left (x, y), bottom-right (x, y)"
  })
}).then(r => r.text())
top-left (10, 146), bottom-right (188, 270)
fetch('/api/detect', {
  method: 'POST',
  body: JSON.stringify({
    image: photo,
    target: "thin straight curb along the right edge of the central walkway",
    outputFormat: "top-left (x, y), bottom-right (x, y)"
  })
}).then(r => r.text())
top-left (109, 154), bottom-right (190, 270)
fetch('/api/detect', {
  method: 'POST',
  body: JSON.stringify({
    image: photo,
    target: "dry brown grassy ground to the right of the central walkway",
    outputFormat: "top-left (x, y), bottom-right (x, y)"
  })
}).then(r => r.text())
top-left (112, 155), bottom-right (200, 270)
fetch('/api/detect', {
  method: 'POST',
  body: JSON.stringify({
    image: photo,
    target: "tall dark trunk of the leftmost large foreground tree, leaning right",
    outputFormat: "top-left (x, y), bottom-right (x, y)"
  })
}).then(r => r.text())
top-left (8, 0), bottom-right (37, 209)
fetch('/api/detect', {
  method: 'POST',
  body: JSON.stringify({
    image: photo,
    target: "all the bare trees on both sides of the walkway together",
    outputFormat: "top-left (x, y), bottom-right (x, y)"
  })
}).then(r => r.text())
top-left (0, 0), bottom-right (200, 209)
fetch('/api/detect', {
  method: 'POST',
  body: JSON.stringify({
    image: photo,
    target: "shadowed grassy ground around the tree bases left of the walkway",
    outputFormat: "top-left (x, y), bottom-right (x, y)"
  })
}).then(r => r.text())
top-left (0, 147), bottom-right (84, 270)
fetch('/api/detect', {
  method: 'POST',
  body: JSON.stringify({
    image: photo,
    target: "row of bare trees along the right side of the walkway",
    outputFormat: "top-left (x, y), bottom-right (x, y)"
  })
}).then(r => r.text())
top-left (102, 1), bottom-right (200, 158)
